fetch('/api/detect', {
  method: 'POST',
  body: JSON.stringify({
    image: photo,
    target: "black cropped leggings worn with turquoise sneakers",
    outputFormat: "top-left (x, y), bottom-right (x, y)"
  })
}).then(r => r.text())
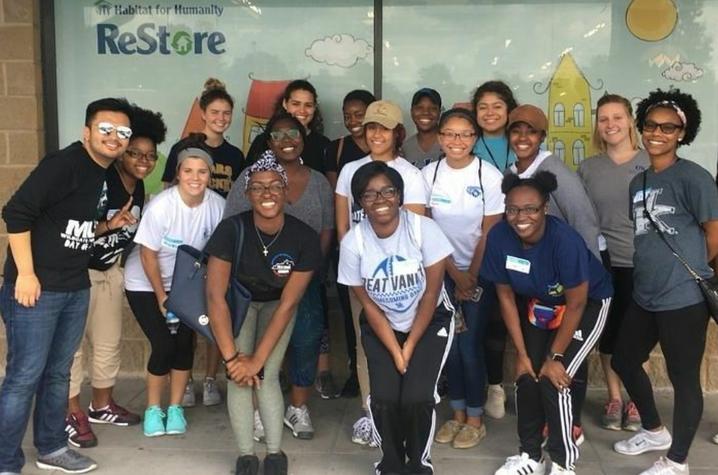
top-left (125, 290), bottom-right (194, 376)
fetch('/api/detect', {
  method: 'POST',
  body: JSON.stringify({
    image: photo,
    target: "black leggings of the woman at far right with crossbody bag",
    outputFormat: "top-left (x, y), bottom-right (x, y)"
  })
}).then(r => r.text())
top-left (611, 301), bottom-right (708, 463)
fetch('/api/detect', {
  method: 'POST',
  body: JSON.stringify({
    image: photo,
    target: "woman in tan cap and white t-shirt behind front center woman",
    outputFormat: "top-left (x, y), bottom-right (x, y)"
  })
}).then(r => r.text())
top-left (334, 101), bottom-right (428, 445)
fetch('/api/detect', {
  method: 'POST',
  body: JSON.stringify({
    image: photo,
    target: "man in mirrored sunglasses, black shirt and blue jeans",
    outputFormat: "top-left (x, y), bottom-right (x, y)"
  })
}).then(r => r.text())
top-left (0, 98), bottom-right (132, 474)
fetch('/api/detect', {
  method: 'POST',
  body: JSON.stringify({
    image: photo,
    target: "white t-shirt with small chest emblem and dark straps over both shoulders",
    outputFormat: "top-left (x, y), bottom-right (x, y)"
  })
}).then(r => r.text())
top-left (421, 158), bottom-right (504, 270)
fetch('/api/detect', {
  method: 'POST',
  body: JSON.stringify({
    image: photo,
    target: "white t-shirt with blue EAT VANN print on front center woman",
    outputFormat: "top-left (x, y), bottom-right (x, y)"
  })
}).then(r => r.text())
top-left (337, 210), bottom-right (453, 332)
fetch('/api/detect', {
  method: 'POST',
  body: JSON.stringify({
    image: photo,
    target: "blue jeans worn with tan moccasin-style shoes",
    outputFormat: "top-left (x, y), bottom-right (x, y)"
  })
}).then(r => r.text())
top-left (444, 274), bottom-right (496, 417)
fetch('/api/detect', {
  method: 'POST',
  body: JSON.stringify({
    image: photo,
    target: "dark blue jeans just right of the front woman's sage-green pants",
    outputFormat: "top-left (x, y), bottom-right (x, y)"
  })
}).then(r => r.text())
top-left (287, 277), bottom-right (324, 388)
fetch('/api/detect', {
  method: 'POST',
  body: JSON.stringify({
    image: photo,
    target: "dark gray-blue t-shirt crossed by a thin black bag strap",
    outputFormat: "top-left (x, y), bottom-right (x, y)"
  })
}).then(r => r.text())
top-left (629, 159), bottom-right (718, 312)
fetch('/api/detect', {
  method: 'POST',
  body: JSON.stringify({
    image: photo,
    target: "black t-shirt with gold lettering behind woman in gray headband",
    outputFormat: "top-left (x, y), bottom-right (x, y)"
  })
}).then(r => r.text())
top-left (162, 140), bottom-right (245, 198)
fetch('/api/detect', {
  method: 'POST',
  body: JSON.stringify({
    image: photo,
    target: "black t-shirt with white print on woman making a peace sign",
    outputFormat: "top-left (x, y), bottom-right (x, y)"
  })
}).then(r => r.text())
top-left (90, 165), bottom-right (145, 270)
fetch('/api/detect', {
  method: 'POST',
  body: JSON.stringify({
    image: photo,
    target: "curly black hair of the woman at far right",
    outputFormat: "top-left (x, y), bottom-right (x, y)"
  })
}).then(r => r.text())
top-left (636, 89), bottom-right (701, 146)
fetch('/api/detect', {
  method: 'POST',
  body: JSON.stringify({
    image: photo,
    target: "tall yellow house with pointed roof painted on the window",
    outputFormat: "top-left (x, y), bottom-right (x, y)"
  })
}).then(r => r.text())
top-left (546, 53), bottom-right (595, 170)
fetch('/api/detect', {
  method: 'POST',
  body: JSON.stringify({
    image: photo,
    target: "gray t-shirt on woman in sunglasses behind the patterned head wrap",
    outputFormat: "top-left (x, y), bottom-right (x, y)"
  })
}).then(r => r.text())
top-left (224, 169), bottom-right (334, 233)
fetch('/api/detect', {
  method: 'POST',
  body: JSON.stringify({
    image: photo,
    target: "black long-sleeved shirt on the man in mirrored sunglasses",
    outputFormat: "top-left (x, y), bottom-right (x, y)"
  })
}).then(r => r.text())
top-left (2, 142), bottom-right (106, 292)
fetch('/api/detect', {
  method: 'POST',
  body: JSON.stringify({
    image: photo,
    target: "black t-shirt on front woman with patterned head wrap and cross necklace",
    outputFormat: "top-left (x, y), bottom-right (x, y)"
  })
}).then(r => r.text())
top-left (205, 211), bottom-right (322, 302)
